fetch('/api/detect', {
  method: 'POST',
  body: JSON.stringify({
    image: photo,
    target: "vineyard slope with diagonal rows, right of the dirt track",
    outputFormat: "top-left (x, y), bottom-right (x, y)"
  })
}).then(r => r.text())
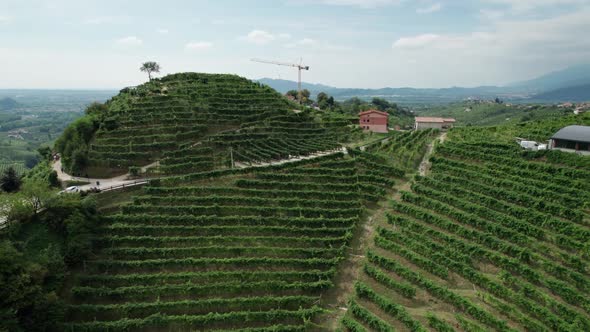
top-left (341, 132), bottom-right (590, 331)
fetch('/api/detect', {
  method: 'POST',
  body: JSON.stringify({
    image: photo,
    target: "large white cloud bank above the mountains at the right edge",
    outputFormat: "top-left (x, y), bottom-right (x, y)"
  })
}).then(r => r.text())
top-left (389, 8), bottom-right (590, 86)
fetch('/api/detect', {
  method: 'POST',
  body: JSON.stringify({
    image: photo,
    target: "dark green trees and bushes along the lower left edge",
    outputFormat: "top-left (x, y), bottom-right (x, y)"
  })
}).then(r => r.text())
top-left (0, 149), bottom-right (98, 331)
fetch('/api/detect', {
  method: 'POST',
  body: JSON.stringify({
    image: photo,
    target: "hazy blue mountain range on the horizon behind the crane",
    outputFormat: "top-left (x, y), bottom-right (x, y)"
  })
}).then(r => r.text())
top-left (258, 64), bottom-right (590, 104)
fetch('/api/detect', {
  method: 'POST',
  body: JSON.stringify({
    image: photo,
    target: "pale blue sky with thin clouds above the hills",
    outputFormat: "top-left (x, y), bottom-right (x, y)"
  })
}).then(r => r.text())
top-left (0, 0), bottom-right (590, 89)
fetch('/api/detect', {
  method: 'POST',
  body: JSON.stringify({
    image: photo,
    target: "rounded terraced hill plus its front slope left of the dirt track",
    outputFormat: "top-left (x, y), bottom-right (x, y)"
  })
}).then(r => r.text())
top-left (55, 74), bottom-right (404, 331)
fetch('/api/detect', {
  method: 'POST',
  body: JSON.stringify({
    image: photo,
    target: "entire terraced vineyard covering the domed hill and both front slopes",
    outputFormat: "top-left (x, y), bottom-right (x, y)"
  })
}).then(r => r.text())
top-left (52, 70), bottom-right (590, 332)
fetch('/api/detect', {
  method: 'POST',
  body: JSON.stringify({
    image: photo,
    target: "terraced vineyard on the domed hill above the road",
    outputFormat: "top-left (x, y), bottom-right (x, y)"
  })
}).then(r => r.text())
top-left (80, 73), bottom-right (348, 174)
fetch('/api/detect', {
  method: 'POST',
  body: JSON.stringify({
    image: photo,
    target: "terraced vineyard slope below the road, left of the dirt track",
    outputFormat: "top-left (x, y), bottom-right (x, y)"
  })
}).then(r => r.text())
top-left (65, 153), bottom-right (403, 331)
